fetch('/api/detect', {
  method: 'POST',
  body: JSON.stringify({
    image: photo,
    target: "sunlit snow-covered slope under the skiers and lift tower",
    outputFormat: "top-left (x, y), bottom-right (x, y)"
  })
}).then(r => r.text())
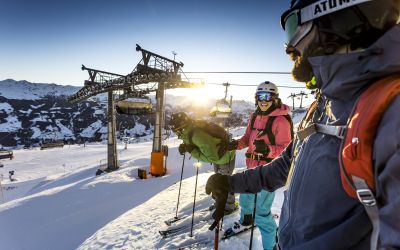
top-left (0, 133), bottom-right (282, 250)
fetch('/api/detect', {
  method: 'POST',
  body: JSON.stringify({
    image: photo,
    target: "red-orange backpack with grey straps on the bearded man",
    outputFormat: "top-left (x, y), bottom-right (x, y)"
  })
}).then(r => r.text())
top-left (339, 73), bottom-right (400, 198)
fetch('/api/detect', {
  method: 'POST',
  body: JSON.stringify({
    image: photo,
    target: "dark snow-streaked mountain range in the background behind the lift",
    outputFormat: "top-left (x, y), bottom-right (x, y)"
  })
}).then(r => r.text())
top-left (0, 79), bottom-right (254, 149)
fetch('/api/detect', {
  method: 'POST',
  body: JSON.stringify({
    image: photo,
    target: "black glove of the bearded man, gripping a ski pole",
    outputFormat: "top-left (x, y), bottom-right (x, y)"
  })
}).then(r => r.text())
top-left (206, 174), bottom-right (230, 230)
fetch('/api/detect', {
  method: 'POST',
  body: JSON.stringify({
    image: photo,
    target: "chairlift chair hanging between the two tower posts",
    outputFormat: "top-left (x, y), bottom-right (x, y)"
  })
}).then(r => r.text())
top-left (116, 98), bottom-right (154, 115)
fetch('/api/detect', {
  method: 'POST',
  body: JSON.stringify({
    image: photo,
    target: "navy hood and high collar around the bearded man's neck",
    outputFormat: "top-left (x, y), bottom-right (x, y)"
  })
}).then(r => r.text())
top-left (309, 24), bottom-right (400, 100)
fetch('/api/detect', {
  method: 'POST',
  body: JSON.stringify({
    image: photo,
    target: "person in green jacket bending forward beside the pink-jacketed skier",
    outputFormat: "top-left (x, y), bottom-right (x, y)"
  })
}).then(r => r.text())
top-left (170, 112), bottom-right (236, 214)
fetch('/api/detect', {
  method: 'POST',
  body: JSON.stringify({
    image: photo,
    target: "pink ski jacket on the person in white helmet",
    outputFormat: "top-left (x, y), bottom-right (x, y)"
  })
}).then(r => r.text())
top-left (237, 104), bottom-right (291, 169)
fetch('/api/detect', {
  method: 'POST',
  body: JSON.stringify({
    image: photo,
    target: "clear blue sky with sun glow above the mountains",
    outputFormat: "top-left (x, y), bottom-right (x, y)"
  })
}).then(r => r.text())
top-left (0, 0), bottom-right (312, 106)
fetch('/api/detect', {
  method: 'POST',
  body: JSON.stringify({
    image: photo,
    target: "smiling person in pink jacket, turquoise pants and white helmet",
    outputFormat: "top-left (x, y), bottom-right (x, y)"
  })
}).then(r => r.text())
top-left (225, 81), bottom-right (293, 249)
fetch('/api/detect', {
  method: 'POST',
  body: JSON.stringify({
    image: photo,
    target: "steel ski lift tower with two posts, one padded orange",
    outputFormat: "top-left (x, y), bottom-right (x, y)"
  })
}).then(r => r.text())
top-left (68, 45), bottom-right (201, 176)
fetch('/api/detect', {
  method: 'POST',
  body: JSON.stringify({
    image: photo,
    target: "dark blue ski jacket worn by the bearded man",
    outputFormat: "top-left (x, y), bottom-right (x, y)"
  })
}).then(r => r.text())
top-left (229, 25), bottom-right (400, 250)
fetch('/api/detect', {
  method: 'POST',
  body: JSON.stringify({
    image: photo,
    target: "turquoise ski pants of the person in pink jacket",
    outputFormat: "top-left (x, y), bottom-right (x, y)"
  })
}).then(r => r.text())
top-left (239, 190), bottom-right (277, 250)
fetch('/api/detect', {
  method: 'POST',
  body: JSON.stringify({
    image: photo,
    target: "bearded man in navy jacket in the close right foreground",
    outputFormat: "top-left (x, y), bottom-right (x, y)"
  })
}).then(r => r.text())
top-left (206, 0), bottom-right (400, 250)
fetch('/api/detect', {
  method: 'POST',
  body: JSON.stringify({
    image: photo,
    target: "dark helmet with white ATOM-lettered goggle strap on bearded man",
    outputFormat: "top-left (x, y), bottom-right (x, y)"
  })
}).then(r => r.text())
top-left (281, 0), bottom-right (400, 54)
